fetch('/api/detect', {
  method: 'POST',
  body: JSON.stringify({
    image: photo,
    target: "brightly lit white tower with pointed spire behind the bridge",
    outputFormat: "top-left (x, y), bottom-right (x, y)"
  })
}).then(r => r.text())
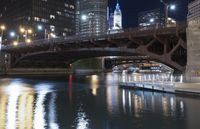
top-left (113, 1), bottom-right (122, 30)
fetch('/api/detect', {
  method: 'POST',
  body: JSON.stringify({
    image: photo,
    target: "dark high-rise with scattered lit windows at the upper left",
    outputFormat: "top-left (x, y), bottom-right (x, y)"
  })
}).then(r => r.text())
top-left (0, 0), bottom-right (75, 38)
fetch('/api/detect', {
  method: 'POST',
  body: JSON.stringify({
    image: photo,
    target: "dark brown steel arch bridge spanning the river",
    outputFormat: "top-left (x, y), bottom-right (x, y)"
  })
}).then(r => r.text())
top-left (1, 23), bottom-right (187, 72)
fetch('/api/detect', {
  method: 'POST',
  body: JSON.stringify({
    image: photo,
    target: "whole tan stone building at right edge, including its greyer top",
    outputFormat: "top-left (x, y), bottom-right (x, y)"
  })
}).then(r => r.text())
top-left (186, 0), bottom-right (200, 82)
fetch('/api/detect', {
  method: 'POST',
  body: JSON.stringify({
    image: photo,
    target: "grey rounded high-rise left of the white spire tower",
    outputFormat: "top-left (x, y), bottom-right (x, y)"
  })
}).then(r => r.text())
top-left (76, 0), bottom-right (107, 36)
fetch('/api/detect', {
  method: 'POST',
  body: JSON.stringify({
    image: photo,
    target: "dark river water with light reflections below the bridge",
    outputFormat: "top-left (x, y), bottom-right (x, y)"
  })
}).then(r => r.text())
top-left (0, 73), bottom-right (200, 129)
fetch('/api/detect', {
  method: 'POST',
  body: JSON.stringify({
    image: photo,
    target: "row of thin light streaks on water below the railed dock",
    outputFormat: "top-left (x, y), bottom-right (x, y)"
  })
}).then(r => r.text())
top-left (116, 89), bottom-right (185, 117)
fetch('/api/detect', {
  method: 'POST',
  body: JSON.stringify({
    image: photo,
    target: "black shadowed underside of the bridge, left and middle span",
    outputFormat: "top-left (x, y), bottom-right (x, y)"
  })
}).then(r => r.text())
top-left (13, 48), bottom-right (141, 68)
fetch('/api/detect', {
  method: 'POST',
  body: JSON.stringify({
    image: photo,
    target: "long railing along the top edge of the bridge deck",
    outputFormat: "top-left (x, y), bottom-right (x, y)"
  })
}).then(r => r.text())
top-left (2, 22), bottom-right (187, 50)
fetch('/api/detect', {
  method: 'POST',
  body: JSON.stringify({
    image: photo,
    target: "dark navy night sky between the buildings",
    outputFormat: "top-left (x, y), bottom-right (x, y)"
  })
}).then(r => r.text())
top-left (109, 0), bottom-right (192, 28)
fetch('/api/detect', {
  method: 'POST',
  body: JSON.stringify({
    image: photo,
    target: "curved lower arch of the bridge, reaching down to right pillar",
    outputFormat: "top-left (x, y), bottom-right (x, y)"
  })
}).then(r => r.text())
top-left (13, 48), bottom-right (184, 71)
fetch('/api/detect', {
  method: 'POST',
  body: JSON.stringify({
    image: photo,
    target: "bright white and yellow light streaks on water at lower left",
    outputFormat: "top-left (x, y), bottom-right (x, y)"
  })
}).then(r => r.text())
top-left (0, 80), bottom-right (58, 129)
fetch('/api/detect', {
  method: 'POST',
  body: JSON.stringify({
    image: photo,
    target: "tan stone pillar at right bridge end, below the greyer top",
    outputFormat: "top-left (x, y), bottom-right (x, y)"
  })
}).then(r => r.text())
top-left (185, 18), bottom-right (200, 82)
